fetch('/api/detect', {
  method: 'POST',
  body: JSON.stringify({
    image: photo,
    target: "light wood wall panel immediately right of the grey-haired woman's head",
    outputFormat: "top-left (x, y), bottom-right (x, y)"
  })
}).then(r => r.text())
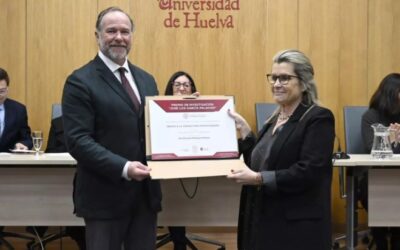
top-left (299, 0), bottom-right (345, 225)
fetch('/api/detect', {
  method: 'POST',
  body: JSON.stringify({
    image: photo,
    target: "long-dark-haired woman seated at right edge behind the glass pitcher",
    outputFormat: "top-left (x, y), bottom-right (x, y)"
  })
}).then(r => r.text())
top-left (360, 73), bottom-right (400, 250)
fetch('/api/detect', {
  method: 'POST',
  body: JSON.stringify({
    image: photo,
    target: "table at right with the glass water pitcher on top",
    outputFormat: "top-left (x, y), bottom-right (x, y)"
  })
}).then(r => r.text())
top-left (333, 154), bottom-right (400, 250)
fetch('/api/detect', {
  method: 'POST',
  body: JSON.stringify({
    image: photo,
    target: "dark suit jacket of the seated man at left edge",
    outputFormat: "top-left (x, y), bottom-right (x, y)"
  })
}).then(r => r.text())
top-left (0, 98), bottom-right (32, 152)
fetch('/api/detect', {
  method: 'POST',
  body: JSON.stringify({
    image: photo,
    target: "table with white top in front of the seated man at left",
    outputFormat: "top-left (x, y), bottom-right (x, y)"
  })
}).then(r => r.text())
top-left (0, 153), bottom-right (83, 226)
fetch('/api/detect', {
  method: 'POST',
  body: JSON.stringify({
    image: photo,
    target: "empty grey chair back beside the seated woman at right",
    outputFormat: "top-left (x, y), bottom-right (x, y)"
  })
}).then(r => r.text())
top-left (343, 106), bottom-right (368, 154)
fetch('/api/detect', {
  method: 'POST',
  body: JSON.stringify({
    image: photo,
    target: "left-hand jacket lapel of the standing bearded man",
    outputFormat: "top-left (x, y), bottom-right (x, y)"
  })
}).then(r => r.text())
top-left (94, 55), bottom-right (136, 114)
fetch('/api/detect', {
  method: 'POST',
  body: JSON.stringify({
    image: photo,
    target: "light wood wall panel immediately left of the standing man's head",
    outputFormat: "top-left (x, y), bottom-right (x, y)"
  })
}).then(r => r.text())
top-left (26, 0), bottom-right (97, 146)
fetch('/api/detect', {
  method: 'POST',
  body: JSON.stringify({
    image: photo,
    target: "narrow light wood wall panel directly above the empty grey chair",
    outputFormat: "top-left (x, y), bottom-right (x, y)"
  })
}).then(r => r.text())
top-left (333, 0), bottom-right (369, 227)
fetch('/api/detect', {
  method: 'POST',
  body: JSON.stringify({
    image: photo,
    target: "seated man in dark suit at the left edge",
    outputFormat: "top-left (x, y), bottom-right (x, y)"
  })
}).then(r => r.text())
top-left (0, 68), bottom-right (32, 152)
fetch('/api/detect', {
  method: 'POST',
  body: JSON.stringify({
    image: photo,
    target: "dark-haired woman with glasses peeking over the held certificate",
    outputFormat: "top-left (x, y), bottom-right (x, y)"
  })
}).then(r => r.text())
top-left (164, 71), bottom-right (198, 250)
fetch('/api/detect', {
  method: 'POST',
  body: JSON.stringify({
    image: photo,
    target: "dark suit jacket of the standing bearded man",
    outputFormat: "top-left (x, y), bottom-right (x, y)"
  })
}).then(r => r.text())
top-left (62, 56), bottom-right (161, 219)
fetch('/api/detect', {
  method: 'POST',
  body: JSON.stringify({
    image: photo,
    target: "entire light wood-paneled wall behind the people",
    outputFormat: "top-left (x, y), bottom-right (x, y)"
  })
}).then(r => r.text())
top-left (0, 0), bottom-right (400, 227)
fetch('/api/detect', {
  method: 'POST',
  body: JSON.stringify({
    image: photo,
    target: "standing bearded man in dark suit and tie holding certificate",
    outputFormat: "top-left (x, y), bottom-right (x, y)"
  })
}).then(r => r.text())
top-left (62, 7), bottom-right (161, 250)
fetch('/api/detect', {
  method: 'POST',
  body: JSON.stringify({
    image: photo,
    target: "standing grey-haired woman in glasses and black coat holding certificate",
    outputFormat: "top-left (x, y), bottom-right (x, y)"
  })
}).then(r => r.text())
top-left (228, 49), bottom-right (335, 250)
